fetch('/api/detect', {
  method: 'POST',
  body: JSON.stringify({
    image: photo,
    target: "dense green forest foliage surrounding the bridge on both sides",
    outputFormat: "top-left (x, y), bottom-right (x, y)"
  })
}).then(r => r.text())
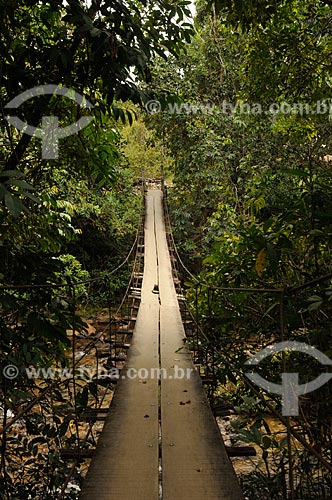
top-left (0, 0), bottom-right (332, 500)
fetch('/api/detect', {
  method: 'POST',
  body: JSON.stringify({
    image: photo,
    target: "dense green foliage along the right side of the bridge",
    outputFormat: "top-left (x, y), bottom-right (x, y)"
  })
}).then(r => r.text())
top-left (148, 0), bottom-right (332, 499)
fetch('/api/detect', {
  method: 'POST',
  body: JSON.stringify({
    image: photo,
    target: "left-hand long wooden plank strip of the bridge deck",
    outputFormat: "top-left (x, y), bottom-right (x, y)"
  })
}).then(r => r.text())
top-left (80, 190), bottom-right (159, 500)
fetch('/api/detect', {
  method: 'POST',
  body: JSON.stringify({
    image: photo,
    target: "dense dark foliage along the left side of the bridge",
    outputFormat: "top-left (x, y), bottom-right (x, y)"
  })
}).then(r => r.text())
top-left (0, 0), bottom-right (192, 499)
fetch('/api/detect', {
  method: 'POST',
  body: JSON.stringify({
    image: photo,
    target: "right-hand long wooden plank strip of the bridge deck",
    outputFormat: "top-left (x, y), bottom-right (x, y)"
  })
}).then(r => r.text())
top-left (148, 188), bottom-right (243, 500)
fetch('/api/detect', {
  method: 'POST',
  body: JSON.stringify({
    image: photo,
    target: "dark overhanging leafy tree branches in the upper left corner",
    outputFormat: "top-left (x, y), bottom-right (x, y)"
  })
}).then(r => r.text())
top-left (0, 0), bottom-right (191, 170)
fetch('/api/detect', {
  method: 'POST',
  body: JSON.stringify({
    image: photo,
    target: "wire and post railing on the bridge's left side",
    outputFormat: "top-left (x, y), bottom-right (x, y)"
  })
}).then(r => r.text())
top-left (0, 193), bottom-right (144, 500)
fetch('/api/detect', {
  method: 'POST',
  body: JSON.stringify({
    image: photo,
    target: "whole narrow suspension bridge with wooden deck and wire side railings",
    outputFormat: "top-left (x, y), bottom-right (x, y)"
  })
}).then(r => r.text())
top-left (0, 186), bottom-right (332, 500)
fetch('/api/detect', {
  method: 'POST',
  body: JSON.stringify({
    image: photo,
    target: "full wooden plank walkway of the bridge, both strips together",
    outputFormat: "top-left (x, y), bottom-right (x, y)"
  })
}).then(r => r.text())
top-left (80, 190), bottom-right (243, 500)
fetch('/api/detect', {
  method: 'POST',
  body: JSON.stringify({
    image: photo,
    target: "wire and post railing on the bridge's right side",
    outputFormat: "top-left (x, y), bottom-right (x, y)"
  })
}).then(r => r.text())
top-left (164, 187), bottom-right (332, 499)
